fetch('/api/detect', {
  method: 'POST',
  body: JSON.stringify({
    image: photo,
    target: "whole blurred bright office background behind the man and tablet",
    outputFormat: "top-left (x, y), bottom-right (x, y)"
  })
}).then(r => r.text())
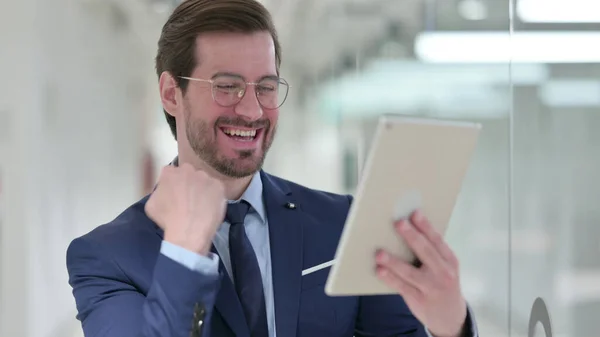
top-left (0, 0), bottom-right (600, 337)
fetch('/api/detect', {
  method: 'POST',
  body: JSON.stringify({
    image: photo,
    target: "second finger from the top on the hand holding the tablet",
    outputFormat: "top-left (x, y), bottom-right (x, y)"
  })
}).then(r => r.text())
top-left (396, 220), bottom-right (445, 270)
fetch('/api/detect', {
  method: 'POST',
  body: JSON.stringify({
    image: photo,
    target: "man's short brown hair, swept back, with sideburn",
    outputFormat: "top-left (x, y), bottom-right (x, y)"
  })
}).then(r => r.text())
top-left (156, 0), bottom-right (281, 139)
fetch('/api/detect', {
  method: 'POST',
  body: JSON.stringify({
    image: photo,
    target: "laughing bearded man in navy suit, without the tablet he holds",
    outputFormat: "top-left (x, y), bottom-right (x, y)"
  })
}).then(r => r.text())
top-left (67, 0), bottom-right (476, 337)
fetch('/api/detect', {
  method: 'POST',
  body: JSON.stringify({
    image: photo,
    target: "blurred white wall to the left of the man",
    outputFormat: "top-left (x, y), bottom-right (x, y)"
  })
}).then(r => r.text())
top-left (0, 0), bottom-right (152, 337)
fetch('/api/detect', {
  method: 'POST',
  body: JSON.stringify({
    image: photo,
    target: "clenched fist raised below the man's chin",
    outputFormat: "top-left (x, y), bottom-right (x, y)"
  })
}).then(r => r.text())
top-left (145, 164), bottom-right (227, 255)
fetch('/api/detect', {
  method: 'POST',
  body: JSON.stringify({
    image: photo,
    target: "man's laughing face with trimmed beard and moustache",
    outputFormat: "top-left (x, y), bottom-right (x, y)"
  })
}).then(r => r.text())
top-left (182, 32), bottom-right (279, 178)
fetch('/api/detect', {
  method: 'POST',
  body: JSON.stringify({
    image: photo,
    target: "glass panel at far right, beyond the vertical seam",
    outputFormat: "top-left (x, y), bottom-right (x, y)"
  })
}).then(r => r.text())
top-left (510, 0), bottom-right (600, 337)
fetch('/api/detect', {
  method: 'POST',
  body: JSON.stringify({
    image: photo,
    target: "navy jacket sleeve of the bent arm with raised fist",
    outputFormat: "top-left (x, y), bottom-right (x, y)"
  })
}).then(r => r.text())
top-left (67, 236), bottom-right (221, 337)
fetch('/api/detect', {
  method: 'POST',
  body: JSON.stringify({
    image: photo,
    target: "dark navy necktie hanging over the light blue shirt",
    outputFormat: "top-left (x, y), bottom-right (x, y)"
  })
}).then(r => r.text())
top-left (225, 200), bottom-right (269, 337)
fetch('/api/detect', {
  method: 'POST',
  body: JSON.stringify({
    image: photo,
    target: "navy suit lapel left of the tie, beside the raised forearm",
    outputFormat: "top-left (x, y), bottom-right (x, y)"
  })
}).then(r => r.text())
top-left (211, 245), bottom-right (250, 336)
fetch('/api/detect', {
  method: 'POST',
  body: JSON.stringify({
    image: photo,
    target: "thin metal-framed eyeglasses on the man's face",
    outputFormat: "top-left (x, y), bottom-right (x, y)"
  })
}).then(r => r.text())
top-left (179, 75), bottom-right (290, 109)
